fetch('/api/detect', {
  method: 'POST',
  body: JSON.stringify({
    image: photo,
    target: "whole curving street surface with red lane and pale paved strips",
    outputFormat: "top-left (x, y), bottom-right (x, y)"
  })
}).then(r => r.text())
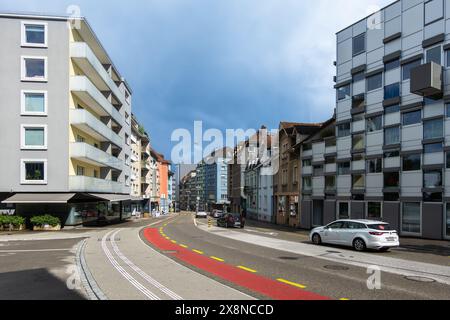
top-left (0, 213), bottom-right (450, 300)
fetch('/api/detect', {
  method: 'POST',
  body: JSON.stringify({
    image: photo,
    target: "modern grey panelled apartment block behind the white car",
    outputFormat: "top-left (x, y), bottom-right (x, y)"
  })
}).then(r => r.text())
top-left (310, 0), bottom-right (450, 239)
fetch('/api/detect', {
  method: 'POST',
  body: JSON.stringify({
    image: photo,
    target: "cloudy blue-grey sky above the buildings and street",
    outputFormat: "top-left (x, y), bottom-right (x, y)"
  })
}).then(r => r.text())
top-left (0, 0), bottom-right (393, 157)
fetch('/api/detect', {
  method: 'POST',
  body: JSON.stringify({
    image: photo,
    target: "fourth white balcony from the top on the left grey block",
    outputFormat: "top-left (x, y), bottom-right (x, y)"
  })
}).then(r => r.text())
top-left (70, 142), bottom-right (123, 171)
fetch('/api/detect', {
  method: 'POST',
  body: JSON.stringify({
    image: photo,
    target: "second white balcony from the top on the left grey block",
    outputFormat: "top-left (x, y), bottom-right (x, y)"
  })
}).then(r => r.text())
top-left (70, 76), bottom-right (124, 127)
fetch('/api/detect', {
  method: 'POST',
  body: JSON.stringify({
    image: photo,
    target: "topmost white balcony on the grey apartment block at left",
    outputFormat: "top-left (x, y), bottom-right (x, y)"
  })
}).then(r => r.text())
top-left (70, 42), bottom-right (126, 105)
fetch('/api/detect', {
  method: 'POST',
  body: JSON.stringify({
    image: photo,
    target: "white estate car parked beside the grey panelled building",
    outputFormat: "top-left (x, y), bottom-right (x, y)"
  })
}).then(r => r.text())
top-left (310, 220), bottom-right (400, 251)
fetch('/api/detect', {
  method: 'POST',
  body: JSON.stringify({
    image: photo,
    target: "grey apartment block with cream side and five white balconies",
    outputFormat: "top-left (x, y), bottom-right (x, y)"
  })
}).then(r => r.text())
top-left (0, 13), bottom-right (132, 224)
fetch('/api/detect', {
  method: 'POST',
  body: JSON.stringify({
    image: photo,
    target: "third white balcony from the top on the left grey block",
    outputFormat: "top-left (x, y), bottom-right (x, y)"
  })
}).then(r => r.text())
top-left (70, 109), bottom-right (123, 147)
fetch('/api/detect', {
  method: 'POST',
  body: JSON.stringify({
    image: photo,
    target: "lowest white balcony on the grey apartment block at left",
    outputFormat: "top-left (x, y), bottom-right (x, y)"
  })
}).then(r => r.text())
top-left (69, 176), bottom-right (126, 193)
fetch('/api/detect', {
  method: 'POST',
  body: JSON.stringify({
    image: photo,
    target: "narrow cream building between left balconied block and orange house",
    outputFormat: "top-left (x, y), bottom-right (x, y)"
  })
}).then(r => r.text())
top-left (130, 114), bottom-right (152, 213)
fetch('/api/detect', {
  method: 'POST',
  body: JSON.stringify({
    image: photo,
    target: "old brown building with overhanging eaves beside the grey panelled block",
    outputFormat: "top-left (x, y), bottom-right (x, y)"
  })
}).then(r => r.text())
top-left (273, 122), bottom-right (321, 228)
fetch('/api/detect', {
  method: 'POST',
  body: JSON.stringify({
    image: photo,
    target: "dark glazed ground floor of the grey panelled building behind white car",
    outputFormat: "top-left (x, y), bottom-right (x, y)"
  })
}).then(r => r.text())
top-left (300, 198), bottom-right (450, 240)
